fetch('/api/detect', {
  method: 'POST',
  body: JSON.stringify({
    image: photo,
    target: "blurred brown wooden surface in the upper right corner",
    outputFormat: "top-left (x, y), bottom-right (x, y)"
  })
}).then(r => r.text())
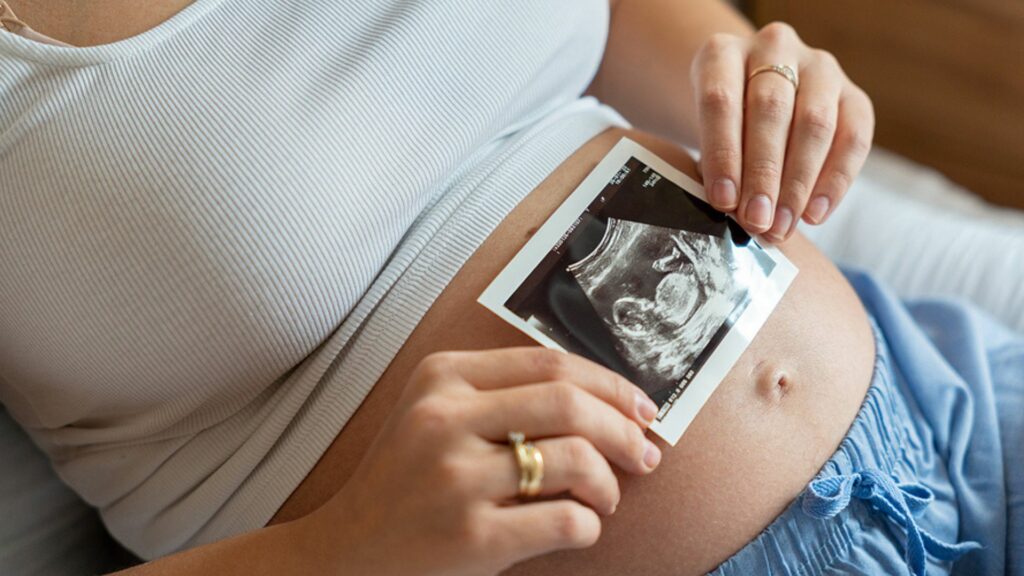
top-left (746, 0), bottom-right (1024, 208)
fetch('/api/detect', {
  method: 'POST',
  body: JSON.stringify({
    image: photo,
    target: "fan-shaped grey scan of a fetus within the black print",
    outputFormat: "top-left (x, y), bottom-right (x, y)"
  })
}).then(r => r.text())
top-left (566, 218), bottom-right (766, 396)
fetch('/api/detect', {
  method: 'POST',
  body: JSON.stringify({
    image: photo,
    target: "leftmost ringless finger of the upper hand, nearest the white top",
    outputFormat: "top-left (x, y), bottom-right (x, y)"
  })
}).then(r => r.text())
top-left (691, 35), bottom-right (746, 212)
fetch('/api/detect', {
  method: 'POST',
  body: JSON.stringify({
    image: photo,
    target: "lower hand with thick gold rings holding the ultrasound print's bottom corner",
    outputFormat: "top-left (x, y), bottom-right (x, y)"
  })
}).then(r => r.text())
top-left (304, 346), bottom-right (660, 575)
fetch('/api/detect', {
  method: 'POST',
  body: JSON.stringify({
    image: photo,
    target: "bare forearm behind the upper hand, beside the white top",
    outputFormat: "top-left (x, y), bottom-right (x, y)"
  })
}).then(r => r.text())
top-left (589, 0), bottom-right (754, 147)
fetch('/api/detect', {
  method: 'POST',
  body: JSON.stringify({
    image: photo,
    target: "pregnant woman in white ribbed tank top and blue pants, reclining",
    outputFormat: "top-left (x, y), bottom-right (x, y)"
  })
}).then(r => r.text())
top-left (0, 0), bottom-right (1024, 575)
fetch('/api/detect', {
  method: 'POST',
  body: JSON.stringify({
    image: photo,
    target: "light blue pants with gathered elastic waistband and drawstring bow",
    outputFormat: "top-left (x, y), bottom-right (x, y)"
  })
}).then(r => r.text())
top-left (714, 271), bottom-right (1024, 576)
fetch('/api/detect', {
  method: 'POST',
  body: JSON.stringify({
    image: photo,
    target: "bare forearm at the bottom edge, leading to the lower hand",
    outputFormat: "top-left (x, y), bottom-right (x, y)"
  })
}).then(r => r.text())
top-left (109, 520), bottom-right (335, 576)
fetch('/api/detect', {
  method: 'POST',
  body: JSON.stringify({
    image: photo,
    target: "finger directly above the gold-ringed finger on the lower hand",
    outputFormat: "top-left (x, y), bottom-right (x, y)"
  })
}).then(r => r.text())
top-left (465, 381), bottom-right (662, 474)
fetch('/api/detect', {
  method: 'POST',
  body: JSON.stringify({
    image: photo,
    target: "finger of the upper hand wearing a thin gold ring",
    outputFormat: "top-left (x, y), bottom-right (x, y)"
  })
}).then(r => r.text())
top-left (736, 27), bottom-right (799, 234)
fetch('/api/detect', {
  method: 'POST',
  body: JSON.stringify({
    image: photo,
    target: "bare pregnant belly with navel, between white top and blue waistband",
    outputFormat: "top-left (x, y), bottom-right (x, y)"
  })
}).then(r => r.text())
top-left (270, 129), bottom-right (874, 576)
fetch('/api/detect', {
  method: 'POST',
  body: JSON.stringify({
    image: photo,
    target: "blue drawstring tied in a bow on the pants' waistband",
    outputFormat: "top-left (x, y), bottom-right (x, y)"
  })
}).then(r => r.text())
top-left (802, 468), bottom-right (981, 576)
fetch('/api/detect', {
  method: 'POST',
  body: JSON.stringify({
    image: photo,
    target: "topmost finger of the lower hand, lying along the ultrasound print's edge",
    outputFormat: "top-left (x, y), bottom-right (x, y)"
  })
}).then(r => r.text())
top-left (423, 346), bottom-right (657, 427)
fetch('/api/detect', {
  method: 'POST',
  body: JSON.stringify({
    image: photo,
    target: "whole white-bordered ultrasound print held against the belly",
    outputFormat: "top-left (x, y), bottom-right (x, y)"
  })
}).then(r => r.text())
top-left (479, 138), bottom-right (797, 444)
